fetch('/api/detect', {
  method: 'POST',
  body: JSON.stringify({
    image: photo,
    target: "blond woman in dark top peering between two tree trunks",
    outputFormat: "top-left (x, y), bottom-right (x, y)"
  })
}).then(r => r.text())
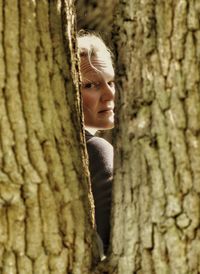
top-left (78, 34), bottom-right (115, 253)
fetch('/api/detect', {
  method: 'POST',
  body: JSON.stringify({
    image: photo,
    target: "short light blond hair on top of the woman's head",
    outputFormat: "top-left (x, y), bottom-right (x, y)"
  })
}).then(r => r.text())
top-left (77, 31), bottom-right (113, 62)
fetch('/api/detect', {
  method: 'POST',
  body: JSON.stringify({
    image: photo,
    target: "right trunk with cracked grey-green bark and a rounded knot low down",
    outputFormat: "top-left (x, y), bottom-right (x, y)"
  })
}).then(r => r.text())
top-left (105, 0), bottom-right (200, 274)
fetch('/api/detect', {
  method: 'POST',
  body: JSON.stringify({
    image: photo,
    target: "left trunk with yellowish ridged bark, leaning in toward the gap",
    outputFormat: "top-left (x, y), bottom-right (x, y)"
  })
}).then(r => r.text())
top-left (0, 0), bottom-right (95, 274)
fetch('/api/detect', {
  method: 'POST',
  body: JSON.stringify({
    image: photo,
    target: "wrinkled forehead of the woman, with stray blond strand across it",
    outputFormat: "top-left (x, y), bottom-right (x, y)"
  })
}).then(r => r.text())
top-left (80, 56), bottom-right (114, 79)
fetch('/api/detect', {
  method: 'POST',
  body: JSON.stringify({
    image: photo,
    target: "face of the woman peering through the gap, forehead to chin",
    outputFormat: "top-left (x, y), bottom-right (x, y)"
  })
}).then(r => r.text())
top-left (81, 56), bottom-right (115, 129)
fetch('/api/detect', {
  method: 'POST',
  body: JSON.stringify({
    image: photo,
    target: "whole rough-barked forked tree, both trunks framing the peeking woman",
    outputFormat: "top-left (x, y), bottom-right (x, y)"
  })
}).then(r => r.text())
top-left (0, 0), bottom-right (200, 274)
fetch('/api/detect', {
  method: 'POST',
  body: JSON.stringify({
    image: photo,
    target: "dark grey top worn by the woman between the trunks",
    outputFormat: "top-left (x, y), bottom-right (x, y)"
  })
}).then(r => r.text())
top-left (86, 131), bottom-right (113, 253)
